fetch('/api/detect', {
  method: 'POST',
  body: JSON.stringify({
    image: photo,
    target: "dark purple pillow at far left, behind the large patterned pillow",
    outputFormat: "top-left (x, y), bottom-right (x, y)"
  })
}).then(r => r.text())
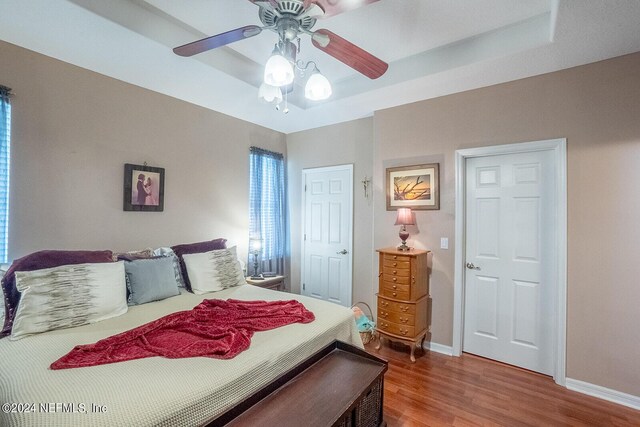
top-left (0, 251), bottom-right (113, 338)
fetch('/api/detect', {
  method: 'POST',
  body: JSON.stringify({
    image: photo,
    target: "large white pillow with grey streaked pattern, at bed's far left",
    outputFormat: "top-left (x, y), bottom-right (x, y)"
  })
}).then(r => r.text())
top-left (11, 262), bottom-right (128, 340)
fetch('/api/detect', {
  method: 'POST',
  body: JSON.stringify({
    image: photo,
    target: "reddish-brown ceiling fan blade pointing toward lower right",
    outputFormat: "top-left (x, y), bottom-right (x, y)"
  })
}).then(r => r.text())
top-left (311, 29), bottom-right (389, 79)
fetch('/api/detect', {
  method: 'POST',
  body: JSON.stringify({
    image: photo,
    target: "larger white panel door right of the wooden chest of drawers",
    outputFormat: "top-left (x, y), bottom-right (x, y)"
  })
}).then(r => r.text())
top-left (463, 151), bottom-right (557, 375)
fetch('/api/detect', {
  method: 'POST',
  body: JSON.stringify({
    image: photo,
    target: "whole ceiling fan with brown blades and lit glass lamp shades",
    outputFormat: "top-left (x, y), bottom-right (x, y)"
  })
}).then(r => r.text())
top-left (173, 0), bottom-right (389, 114)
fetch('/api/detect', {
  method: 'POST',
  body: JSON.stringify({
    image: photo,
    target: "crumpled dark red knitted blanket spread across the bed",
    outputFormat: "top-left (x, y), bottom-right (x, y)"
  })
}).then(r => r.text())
top-left (51, 299), bottom-right (315, 369)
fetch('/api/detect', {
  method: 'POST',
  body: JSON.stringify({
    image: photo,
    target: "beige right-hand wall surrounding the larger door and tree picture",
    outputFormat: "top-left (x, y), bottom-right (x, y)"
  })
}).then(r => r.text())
top-left (373, 53), bottom-right (640, 396)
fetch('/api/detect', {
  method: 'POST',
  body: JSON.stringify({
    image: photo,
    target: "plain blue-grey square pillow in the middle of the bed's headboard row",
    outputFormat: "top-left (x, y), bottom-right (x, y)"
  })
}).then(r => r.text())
top-left (124, 257), bottom-right (180, 305)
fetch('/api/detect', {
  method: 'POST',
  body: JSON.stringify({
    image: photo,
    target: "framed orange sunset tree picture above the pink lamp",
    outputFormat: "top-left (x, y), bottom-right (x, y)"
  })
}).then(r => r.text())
top-left (386, 163), bottom-right (440, 211)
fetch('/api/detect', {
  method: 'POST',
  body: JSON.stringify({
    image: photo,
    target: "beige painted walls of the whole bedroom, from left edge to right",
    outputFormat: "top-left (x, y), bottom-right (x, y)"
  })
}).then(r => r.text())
top-left (0, 38), bottom-right (640, 395)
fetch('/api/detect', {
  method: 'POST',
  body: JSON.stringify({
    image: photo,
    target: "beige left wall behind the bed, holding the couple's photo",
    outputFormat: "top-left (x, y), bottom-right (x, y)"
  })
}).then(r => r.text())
top-left (0, 42), bottom-right (286, 264)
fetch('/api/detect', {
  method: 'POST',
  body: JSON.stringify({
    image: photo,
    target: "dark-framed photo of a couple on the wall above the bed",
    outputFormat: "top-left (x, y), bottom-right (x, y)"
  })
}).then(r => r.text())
top-left (124, 163), bottom-right (164, 212)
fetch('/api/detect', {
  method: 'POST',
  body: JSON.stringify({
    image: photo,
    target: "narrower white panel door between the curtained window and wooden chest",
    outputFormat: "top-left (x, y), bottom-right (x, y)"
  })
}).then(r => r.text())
top-left (302, 165), bottom-right (353, 307)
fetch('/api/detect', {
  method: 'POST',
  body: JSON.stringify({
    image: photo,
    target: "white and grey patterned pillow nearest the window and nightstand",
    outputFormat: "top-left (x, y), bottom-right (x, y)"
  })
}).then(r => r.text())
top-left (183, 246), bottom-right (247, 294)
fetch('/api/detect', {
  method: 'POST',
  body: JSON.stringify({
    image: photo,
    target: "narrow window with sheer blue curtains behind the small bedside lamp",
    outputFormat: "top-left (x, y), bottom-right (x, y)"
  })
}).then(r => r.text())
top-left (249, 147), bottom-right (287, 274)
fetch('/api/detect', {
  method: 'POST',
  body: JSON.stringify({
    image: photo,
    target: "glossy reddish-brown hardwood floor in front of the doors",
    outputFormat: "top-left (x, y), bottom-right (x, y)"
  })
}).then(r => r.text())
top-left (366, 340), bottom-right (640, 427)
